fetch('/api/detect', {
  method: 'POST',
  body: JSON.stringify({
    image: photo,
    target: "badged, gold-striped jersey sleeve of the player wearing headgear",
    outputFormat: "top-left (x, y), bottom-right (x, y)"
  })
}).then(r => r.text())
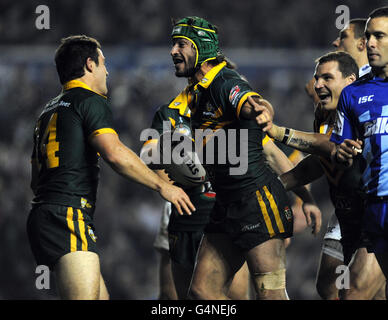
top-left (221, 78), bottom-right (260, 118)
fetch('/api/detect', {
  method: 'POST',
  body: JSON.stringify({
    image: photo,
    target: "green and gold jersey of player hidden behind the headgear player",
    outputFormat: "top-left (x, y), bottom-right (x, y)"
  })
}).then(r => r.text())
top-left (145, 99), bottom-right (215, 231)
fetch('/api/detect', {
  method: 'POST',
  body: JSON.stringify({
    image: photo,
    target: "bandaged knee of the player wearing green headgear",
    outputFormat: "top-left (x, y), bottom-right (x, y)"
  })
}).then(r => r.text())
top-left (253, 268), bottom-right (287, 299)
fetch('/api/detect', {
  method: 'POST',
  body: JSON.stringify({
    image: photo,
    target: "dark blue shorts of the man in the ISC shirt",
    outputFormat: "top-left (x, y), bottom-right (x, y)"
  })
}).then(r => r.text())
top-left (364, 200), bottom-right (388, 253)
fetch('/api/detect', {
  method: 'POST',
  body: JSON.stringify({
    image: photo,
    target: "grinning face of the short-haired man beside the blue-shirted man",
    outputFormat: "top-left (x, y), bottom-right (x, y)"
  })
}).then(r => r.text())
top-left (314, 61), bottom-right (355, 111)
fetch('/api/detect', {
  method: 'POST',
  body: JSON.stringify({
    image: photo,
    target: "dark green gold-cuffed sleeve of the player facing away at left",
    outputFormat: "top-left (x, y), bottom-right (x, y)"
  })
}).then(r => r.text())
top-left (80, 97), bottom-right (116, 138)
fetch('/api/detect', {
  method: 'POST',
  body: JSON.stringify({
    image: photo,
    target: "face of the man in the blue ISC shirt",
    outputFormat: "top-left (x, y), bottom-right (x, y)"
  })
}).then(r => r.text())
top-left (365, 17), bottom-right (388, 76)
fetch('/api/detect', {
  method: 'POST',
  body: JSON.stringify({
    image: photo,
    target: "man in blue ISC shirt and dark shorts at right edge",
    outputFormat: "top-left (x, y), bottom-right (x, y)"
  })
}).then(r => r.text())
top-left (331, 7), bottom-right (388, 284)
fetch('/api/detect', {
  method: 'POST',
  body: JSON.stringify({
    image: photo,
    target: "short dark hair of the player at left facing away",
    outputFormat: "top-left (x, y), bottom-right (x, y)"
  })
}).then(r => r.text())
top-left (55, 35), bottom-right (101, 84)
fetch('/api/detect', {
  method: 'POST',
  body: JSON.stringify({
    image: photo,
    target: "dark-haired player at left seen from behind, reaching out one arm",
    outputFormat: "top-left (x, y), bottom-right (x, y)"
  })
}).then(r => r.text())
top-left (27, 35), bottom-right (195, 299)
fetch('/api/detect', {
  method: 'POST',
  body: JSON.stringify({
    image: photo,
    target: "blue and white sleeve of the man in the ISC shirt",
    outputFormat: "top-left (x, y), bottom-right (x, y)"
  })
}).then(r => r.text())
top-left (330, 89), bottom-right (356, 144)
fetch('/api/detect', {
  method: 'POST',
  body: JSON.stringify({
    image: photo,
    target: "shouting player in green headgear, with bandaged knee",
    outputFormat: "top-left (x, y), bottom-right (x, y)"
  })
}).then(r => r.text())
top-left (167, 17), bottom-right (320, 299)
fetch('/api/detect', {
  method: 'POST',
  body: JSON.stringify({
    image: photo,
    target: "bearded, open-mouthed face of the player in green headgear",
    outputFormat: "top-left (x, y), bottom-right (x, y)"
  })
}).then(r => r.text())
top-left (170, 38), bottom-right (197, 78)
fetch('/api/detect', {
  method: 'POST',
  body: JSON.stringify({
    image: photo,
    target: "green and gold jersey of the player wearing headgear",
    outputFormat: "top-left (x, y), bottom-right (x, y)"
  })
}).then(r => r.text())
top-left (190, 62), bottom-right (274, 201)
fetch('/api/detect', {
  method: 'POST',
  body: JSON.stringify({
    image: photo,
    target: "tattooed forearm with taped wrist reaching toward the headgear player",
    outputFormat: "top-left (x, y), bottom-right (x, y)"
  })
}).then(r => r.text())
top-left (268, 124), bottom-right (336, 157)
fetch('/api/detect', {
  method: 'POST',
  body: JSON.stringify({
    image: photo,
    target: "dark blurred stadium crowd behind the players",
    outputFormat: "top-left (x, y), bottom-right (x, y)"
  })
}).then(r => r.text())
top-left (0, 0), bottom-right (386, 299)
